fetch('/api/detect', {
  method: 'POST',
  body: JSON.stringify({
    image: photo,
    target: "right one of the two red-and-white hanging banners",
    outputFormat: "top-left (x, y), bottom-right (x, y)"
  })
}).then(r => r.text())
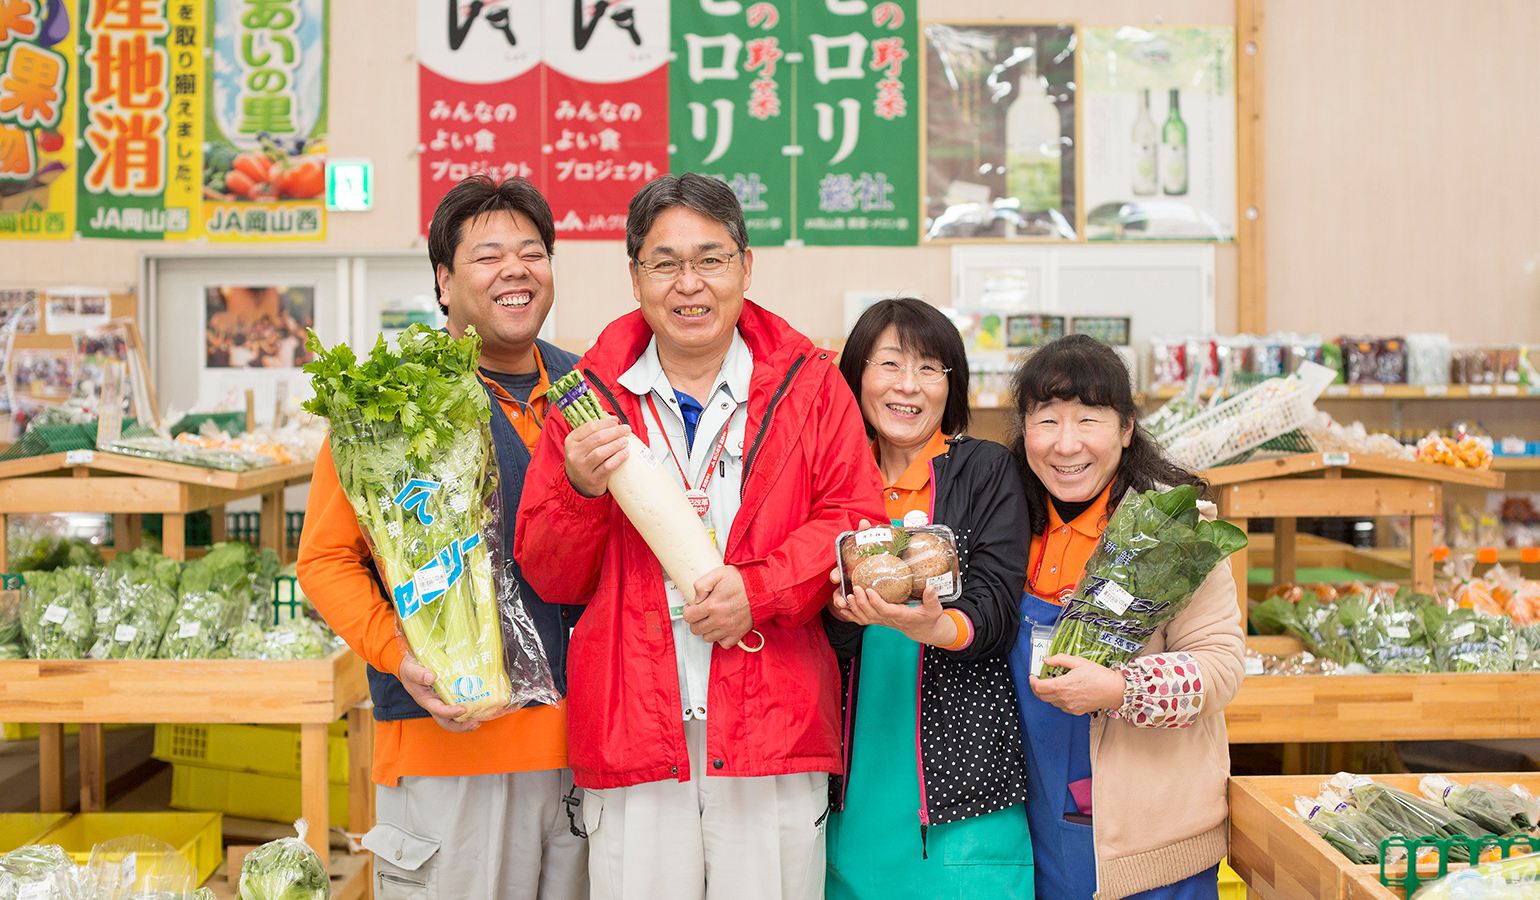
top-left (541, 0), bottom-right (668, 240)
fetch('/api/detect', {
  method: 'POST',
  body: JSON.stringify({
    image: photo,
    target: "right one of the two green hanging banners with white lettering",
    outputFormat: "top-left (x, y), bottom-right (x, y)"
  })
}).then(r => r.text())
top-left (796, 0), bottom-right (919, 245)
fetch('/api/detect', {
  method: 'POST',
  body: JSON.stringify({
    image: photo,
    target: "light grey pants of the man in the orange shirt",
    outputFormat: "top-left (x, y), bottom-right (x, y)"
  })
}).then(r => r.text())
top-left (363, 769), bottom-right (588, 900)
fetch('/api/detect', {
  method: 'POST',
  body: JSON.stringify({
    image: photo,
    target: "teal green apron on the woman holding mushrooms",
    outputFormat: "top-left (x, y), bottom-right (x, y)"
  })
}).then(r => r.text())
top-left (825, 626), bottom-right (1033, 900)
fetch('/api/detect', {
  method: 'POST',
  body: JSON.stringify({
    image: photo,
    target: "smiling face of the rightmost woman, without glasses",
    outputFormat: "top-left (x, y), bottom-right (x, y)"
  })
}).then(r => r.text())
top-left (1021, 401), bottom-right (1133, 502)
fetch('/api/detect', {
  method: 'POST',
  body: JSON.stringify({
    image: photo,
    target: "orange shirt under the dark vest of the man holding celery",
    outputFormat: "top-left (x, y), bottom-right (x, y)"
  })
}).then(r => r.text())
top-left (299, 351), bottom-right (567, 786)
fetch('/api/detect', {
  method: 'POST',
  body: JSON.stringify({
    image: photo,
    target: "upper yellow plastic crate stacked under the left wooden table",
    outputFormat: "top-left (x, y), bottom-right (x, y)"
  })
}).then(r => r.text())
top-left (151, 721), bottom-right (348, 784)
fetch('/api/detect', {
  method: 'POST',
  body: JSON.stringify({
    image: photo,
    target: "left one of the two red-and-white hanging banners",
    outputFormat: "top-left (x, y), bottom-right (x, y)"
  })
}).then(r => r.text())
top-left (417, 0), bottom-right (544, 234)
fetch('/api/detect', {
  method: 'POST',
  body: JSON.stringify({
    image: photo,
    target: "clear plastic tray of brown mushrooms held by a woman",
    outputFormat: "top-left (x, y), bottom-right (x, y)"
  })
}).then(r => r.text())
top-left (835, 526), bottom-right (963, 606)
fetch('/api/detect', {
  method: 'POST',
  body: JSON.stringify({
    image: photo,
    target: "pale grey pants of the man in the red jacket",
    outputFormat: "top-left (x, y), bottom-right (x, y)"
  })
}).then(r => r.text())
top-left (584, 720), bottom-right (829, 900)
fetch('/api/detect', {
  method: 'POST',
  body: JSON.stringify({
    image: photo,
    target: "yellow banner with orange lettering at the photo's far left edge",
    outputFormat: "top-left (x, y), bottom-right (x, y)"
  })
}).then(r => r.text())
top-left (0, 0), bottom-right (75, 239)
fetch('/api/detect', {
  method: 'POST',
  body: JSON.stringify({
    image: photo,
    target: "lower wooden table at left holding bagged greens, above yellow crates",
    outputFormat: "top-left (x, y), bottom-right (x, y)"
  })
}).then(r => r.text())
top-left (0, 647), bottom-right (374, 854)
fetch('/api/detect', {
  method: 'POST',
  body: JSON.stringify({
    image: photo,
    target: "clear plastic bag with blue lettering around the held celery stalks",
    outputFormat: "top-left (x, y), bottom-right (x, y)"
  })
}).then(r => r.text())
top-left (321, 397), bottom-right (561, 721)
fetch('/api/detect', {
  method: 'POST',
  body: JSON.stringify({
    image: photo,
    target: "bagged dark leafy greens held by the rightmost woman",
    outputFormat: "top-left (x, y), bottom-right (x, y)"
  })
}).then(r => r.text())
top-left (1044, 485), bottom-right (1246, 677)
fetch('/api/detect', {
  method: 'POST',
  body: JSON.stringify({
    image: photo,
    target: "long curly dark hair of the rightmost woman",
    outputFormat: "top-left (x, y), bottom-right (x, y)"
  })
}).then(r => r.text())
top-left (1010, 334), bottom-right (1209, 535)
